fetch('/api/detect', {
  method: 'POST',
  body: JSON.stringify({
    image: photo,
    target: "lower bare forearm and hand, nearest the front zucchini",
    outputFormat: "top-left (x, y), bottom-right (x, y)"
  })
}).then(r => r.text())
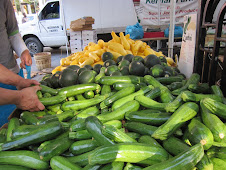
top-left (0, 86), bottom-right (45, 112)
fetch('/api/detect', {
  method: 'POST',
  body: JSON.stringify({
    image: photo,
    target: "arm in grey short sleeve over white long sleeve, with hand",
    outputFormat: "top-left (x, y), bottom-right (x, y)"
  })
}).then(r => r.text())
top-left (5, 0), bottom-right (32, 68)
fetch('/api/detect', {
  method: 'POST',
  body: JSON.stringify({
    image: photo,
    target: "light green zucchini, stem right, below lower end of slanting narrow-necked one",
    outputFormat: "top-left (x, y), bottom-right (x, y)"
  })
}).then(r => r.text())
top-left (135, 95), bottom-right (167, 111)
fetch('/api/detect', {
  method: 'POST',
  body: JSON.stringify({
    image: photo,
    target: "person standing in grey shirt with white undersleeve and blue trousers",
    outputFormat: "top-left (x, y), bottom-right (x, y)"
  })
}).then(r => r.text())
top-left (0, 0), bottom-right (43, 125)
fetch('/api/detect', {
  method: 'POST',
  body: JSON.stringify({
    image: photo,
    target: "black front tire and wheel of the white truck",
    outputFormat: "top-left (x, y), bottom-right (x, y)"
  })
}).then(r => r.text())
top-left (25, 37), bottom-right (43, 57)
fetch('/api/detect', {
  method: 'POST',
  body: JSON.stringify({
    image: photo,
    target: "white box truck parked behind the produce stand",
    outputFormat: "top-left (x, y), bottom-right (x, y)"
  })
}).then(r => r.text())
top-left (19, 0), bottom-right (137, 55)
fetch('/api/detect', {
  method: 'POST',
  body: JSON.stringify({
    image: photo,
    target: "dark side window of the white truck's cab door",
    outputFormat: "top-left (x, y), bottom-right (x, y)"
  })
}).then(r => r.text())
top-left (39, 1), bottom-right (60, 20)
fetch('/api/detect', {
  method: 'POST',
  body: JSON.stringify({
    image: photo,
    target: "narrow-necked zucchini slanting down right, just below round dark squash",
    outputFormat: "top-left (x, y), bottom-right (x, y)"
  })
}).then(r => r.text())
top-left (144, 75), bottom-right (174, 103)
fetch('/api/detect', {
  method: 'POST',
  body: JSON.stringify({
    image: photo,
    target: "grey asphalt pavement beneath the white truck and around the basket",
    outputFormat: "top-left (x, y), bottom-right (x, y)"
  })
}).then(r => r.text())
top-left (17, 47), bottom-right (70, 81)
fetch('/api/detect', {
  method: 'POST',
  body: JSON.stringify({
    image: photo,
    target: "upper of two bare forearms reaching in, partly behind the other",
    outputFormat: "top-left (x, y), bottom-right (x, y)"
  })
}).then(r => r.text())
top-left (0, 64), bottom-right (39, 90)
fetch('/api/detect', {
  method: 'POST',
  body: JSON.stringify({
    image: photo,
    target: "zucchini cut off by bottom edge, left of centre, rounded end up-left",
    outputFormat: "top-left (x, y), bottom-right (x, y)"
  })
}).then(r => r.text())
top-left (50, 156), bottom-right (81, 170)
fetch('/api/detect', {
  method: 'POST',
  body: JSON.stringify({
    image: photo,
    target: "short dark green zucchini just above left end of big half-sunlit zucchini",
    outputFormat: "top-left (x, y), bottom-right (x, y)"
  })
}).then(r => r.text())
top-left (69, 139), bottom-right (99, 155)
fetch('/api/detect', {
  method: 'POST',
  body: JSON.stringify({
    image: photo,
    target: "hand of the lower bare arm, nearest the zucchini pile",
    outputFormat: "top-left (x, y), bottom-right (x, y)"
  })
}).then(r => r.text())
top-left (16, 86), bottom-right (45, 112)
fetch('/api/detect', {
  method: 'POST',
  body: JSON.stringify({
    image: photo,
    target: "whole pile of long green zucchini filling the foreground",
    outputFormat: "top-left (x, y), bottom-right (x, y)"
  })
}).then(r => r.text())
top-left (0, 74), bottom-right (226, 170)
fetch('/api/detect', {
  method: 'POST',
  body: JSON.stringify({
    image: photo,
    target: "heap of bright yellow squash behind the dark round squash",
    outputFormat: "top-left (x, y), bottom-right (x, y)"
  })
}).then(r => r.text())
top-left (52, 31), bottom-right (175, 74)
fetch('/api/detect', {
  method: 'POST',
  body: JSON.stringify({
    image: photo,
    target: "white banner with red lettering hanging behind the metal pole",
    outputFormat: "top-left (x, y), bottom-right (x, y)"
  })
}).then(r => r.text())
top-left (136, 0), bottom-right (198, 25)
